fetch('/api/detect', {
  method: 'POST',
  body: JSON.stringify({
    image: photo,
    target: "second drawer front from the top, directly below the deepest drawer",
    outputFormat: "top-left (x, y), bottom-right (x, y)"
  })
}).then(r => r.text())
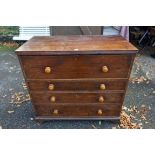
top-left (27, 79), bottom-right (127, 92)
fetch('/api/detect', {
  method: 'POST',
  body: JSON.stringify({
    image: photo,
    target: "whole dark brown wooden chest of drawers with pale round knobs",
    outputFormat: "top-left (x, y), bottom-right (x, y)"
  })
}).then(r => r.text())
top-left (16, 35), bottom-right (137, 120)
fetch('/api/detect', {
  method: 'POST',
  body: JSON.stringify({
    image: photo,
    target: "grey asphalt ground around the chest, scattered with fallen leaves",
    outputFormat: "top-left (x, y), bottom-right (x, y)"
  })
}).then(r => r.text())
top-left (0, 47), bottom-right (155, 129)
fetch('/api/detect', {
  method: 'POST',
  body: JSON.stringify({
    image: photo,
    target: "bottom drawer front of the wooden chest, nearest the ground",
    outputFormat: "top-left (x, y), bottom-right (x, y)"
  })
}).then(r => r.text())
top-left (35, 104), bottom-right (121, 117)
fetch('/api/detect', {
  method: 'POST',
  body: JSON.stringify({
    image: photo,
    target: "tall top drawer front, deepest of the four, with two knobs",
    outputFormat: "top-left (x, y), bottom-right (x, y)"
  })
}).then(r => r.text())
top-left (20, 55), bottom-right (132, 79)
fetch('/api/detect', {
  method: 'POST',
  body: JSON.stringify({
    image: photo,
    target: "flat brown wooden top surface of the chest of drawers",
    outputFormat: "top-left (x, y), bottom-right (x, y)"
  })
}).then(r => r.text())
top-left (16, 35), bottom-right (137, 55)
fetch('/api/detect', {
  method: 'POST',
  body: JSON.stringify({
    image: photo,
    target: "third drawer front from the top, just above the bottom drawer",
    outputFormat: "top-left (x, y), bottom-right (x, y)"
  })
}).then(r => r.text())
top-left (31, 92), bottom-right (124, 105)
